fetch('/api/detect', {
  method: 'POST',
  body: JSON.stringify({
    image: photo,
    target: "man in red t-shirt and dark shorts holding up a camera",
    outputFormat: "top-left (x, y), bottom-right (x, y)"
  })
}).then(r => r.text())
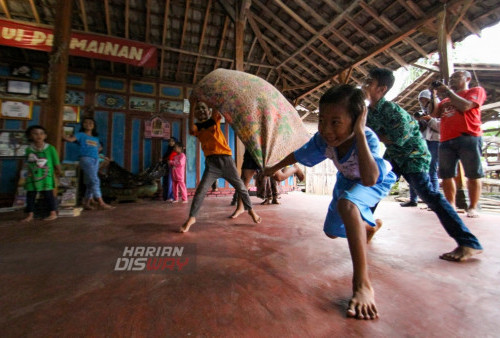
top-left (431, 70), bottom-right (486, 217)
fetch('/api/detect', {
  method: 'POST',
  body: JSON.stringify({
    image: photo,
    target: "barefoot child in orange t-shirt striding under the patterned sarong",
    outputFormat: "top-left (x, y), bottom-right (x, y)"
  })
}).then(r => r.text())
top-left (179, 101), bottom-right (261, 232)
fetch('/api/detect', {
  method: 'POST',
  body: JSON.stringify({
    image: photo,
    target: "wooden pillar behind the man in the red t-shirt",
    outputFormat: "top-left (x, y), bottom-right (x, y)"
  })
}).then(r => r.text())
top-left (438, 10), bottom-right (468, 209)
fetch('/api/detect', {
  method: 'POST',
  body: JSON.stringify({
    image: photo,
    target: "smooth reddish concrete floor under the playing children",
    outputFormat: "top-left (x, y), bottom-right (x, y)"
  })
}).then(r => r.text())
top-left (0, 192), bottom-right (500, 337)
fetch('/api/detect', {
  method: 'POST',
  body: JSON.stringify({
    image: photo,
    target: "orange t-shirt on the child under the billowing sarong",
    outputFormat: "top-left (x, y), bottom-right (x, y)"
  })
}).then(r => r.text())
top-left (193, 113), bottom-right (233, 156)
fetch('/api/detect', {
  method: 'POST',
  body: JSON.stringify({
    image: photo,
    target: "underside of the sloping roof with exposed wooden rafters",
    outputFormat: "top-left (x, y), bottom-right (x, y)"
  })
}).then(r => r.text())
top-left (0, 0), bottom-right (500, 116)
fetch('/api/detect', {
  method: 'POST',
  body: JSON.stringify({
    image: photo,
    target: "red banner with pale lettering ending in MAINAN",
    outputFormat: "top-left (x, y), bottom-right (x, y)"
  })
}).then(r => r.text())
top-left (0, 19), bottom-right (158, 68)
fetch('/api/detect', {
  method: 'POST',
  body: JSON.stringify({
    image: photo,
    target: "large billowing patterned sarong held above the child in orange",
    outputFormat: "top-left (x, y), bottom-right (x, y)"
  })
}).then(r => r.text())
top-left (190, 69), bottom-right (310, 167)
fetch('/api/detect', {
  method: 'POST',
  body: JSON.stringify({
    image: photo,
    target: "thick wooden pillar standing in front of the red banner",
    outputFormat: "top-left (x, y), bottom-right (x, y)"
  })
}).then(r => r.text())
top-left (43, 0), bottom-right (73, 154)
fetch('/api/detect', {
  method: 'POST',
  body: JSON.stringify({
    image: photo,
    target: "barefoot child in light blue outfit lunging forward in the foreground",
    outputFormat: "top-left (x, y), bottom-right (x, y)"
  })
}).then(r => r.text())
top-left (265, 85), bottom-right (396, 319)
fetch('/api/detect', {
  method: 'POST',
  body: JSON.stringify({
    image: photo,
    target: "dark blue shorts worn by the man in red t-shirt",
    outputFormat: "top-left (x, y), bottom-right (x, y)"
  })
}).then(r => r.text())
top-left (439, 135), bottom-right (484, 179)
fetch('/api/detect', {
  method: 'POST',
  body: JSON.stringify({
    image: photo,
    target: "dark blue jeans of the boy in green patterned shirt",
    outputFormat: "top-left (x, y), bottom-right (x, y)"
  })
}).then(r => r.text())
top-left (403, 173), bottom-right (482, 250)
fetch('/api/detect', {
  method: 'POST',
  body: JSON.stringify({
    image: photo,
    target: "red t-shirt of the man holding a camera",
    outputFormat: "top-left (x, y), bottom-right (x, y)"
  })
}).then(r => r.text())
top-left (439, 87), bottom-right (486, 142)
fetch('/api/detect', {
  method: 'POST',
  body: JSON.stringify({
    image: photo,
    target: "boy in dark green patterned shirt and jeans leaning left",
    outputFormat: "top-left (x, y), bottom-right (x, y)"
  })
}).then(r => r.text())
top-left (362, 68), bottom-right (483, 261)
